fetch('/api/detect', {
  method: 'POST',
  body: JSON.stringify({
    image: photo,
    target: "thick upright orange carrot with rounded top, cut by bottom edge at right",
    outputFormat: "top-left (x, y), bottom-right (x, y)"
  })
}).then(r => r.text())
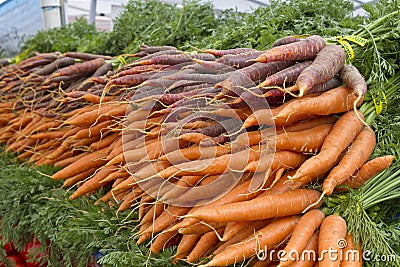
top-left (318, 214), bottom-right (347, 267)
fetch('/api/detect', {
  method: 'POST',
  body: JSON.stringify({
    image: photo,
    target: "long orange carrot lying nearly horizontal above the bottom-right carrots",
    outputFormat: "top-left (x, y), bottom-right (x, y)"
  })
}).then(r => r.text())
top-left (188, 189), bottom-right (322, 222)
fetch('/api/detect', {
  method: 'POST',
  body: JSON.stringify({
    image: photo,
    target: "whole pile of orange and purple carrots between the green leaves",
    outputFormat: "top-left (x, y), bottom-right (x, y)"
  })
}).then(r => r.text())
top-left (0, 35), bottom-right (393, 266)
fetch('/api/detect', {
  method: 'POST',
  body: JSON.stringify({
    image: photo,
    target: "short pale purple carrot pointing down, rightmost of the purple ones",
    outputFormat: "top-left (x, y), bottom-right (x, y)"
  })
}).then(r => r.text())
top-left (340, 64), bottom-right (367, 110)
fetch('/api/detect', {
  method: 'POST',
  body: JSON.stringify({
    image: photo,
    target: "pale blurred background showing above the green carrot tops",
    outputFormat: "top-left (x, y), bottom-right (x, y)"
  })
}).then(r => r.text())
top-left (0, 0), bottom-right (373, 55)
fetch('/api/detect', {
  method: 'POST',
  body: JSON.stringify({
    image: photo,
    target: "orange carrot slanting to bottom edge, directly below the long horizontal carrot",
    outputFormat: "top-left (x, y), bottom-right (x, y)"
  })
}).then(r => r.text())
top-left (201, 216), bottom-right (299, 267)
